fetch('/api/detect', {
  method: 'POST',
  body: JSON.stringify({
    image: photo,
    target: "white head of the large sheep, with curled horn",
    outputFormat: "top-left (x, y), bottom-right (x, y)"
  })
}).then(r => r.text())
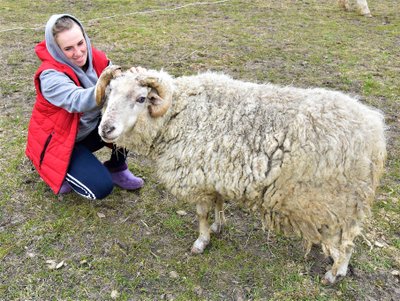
top-left (99, 70), bottom-right (172, 142)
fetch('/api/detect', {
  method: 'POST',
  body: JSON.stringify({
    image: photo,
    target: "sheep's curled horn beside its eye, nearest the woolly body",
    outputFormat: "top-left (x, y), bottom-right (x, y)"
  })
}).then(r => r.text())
top-left (140, 77), bottom-right (172, 118)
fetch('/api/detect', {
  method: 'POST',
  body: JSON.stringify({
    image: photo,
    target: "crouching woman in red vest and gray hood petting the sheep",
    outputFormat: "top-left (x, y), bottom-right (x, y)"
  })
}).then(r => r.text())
top-left (26, 14), bottom-right (143, 199)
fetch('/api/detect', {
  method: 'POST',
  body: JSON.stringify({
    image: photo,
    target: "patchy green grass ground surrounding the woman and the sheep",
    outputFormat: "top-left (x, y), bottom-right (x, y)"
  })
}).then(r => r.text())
top-left (0, 0), bottom-right (400, 301)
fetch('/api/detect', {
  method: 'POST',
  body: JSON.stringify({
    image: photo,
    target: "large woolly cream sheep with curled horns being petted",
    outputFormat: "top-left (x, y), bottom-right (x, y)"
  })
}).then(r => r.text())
top-left (96, 64), bottom-right (386, 283)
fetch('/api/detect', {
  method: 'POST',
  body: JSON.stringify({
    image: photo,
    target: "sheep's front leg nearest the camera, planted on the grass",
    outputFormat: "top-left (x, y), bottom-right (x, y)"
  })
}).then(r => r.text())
top-left (191, 202), bottom-right (210, 254)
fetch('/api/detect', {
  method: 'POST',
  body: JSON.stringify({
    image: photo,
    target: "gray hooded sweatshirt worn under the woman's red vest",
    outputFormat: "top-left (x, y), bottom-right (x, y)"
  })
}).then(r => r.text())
top-left (40, 14), bottom-right (110, 141)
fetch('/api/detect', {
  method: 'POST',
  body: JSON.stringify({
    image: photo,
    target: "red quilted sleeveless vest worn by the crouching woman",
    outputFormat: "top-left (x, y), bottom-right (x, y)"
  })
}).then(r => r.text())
top-left (25, 41), bottom-right (109, 193)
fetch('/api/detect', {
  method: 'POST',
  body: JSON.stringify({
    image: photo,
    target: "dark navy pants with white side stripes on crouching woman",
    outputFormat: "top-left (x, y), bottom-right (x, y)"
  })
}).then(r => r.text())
top-left (65, 128), bottom-right (127, 200)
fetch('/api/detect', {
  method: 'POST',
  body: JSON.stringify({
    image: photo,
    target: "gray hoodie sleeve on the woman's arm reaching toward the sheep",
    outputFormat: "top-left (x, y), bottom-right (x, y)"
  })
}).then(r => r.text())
top-left (40, 69), bottom-right (98, 113)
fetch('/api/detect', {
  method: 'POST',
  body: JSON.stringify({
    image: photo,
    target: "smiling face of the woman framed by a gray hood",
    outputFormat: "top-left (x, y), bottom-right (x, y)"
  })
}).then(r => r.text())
top-left (56, 24), bottom-right (87, 67)
